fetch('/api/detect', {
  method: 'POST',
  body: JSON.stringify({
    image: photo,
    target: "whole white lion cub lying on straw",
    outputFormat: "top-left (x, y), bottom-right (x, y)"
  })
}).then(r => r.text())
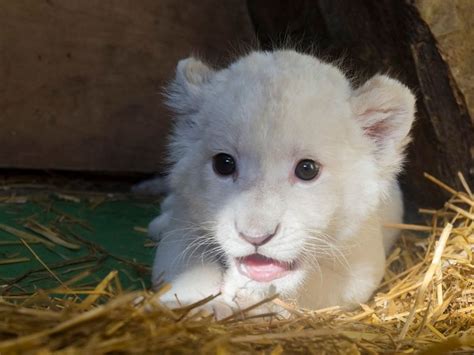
top-left (149, 50), bottom-right (415, 309)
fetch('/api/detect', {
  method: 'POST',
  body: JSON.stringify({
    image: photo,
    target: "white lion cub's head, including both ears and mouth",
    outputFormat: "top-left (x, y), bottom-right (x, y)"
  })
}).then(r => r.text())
top-left (164, 51), bottom-right (414, 291)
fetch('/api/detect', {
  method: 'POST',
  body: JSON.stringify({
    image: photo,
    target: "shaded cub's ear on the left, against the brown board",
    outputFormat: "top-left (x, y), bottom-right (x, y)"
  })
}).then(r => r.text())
top-left (165, 57), bottom-right (215, 114)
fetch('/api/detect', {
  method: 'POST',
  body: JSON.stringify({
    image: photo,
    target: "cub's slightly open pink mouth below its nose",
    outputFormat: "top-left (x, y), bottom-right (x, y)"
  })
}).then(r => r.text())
top-left (236, 254), bottom-right (296, 282)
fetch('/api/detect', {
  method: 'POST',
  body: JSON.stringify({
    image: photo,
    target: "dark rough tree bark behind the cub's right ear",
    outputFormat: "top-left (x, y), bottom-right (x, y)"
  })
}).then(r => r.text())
top-left (247, 0), bottom-right (474, 216)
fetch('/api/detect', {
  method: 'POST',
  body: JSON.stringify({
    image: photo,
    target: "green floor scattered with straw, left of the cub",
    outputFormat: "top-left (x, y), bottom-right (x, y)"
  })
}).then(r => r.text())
top-left (0, 194), bottom-right (159, 296)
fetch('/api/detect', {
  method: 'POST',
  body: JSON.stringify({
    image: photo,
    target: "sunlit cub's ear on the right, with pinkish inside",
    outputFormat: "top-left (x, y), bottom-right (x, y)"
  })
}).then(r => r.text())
top-left (350, 75), bottom-right (415, 177)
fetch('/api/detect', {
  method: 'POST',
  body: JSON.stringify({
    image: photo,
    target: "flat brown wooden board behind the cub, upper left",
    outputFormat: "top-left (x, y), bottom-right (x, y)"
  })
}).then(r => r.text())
top-left (0, 0), bottom-right (253, 172)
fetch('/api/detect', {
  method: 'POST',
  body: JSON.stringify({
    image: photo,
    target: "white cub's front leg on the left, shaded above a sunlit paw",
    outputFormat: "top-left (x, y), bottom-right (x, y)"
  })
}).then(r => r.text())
top-left (148, 199), bottom-right (228, 307)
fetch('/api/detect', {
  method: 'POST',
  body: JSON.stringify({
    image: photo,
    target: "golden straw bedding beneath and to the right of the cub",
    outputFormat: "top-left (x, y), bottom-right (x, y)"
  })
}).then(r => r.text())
top-left (0, 175), bottom-right (474, 354)
